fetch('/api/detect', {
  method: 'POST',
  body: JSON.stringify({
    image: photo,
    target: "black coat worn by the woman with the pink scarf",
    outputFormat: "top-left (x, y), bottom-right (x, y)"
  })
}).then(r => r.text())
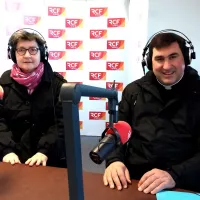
top-left (0, 63), bottom-right (66, 166)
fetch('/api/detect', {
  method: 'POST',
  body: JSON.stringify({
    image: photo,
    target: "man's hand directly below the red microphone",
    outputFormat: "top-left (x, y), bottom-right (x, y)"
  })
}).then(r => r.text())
top-left (103, 161), bottom-right (131, 190)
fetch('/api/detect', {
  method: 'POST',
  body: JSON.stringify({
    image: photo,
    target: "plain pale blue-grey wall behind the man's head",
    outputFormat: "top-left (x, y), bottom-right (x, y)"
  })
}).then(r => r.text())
top-left (148, 0), bottom-right (200, 72)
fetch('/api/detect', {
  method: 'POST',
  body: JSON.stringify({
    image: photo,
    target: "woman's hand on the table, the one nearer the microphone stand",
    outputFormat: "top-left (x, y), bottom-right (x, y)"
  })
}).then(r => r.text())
top-left (25, 152), bottom-right (48, 166)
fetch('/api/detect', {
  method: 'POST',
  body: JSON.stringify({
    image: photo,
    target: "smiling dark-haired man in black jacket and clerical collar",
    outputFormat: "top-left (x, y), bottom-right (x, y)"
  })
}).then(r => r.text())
top-left (103, 32), bottom-right (200, 194)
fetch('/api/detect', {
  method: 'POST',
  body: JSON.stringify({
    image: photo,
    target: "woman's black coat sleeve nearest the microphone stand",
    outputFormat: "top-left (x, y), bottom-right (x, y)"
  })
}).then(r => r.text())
top-left (38, 76), bottom-right (67, 156)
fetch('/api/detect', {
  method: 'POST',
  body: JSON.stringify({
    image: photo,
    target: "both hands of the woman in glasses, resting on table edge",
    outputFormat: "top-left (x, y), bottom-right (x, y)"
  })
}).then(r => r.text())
top-left (2, 152), bottom-right (48, 166)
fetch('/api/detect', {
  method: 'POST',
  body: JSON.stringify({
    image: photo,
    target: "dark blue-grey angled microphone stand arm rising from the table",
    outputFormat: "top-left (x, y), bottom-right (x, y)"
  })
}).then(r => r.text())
top-left (60, 82), bottom-right (118, 200)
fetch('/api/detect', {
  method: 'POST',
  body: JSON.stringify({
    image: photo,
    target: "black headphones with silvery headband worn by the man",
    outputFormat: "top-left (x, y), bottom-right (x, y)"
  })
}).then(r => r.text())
top-left (142, 29), bottom-right (196, 74)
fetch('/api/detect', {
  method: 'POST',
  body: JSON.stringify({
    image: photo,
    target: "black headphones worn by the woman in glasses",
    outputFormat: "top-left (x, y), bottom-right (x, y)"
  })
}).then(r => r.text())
top-left (7, 28), bottom-right (49, 63)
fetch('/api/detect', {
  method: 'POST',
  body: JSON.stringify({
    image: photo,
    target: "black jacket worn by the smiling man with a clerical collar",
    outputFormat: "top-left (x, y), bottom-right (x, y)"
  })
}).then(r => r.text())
top-left (107, 67), bottom-right (200, 192)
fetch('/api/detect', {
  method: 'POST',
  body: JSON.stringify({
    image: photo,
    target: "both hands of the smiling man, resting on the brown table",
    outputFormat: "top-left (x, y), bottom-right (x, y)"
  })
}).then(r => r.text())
top-left (103, 161), bottom-right (176, 194)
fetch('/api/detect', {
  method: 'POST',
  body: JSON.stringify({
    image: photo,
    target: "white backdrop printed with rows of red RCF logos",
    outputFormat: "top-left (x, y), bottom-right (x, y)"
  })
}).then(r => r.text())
top-left (0, 0), bottom-right (148, 135)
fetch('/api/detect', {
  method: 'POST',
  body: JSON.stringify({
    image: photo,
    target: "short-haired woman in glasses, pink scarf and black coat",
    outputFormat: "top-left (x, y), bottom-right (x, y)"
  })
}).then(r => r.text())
top-left (0, 29), bottom-right (67, 167)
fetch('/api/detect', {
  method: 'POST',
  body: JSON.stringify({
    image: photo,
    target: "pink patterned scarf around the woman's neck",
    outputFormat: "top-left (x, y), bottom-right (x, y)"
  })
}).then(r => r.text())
top-left (10, 62), bottom-right (44, 94)
